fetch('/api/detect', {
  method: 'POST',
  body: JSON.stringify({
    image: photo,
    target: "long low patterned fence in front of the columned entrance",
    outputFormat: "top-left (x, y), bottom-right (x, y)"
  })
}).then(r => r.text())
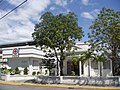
top-left (35, 76), bottom-right (120, 86)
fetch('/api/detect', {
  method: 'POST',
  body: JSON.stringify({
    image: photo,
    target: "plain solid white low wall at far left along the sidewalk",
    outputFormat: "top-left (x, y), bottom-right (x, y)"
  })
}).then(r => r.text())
top-left (0, 75), bottom-right (35, 81)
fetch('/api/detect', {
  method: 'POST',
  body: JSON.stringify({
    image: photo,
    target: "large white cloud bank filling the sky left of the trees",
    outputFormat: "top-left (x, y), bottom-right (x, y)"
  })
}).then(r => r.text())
top-left (0, 0), bottom-right (50, 44)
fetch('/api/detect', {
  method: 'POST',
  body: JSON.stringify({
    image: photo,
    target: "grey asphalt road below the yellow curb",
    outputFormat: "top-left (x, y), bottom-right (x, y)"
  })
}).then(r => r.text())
top-left (0, 84), bottom-right (83, 90)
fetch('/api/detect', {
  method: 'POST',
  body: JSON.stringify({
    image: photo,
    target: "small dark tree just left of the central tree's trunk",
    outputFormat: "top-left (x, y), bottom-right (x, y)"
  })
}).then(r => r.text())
top-left (42, 53), bottom-right (56, 75)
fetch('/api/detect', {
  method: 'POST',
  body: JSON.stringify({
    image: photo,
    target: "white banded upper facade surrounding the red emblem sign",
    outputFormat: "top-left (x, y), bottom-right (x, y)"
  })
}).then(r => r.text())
top-left (2, 46), bottom-right (45, 58)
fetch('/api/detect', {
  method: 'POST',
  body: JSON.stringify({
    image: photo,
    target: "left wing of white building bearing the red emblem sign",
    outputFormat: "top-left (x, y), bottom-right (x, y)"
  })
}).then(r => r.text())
top-left (0, 42), bottom-right (49, 75)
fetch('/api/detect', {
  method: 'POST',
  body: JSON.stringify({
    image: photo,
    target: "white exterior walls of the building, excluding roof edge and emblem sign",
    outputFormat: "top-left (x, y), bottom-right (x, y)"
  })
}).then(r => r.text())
top-left (2, 44), bottom-right (112, 76)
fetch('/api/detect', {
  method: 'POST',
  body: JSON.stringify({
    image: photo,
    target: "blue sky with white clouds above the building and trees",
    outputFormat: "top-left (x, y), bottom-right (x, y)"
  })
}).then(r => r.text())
top-left (0, 0), bottom-right (120, 45)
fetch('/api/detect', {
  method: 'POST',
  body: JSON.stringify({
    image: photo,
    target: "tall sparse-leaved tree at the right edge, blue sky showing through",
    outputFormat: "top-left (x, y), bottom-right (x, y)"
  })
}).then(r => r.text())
top-left (88, 8), bottom-right (120, 75)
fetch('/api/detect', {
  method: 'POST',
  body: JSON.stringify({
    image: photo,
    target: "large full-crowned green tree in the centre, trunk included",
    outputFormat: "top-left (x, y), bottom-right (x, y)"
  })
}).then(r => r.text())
top-left (32, 12), bottom-right (83, 75)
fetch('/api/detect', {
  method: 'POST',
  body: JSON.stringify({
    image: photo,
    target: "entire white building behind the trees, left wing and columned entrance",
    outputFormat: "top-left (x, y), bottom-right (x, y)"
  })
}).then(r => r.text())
top-left (0, 42), bottom-right (112, 76)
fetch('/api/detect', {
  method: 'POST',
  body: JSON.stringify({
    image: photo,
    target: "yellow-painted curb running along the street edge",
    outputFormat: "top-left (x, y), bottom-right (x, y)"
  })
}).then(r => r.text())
top-left (0, 81), bottom-right (120, 90)
